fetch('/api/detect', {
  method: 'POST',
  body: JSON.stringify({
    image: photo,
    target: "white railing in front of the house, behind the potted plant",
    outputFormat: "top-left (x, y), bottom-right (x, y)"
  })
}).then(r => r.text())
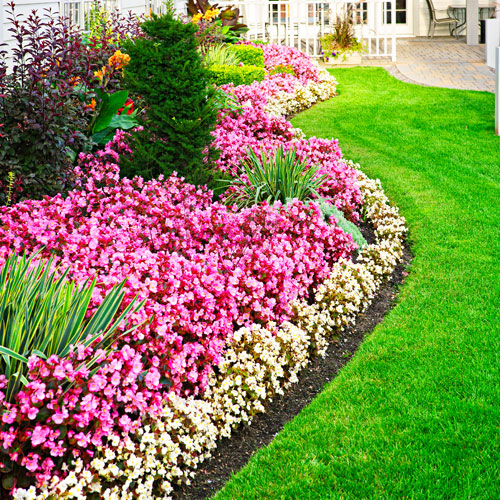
top-left (219, 0), bottom-right (396, 61)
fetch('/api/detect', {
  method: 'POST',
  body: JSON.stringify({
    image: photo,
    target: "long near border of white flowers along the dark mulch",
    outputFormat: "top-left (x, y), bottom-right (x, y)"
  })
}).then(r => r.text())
top-left (14, 148), bottom-right (406, 500)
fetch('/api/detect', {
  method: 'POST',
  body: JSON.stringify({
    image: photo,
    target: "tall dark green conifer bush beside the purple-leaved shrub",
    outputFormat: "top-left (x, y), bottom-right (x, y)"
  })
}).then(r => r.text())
top-left (120, 13), bottom-right (217, 184)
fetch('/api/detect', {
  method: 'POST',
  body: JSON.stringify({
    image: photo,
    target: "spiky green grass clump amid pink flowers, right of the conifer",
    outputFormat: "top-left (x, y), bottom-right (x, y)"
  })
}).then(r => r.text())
top-left (225, 146), bottom-right (326, 209)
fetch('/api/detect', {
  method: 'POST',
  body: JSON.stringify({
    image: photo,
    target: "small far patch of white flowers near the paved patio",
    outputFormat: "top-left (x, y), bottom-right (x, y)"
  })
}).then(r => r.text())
top-left (265, 69), bottom-right (337, 117)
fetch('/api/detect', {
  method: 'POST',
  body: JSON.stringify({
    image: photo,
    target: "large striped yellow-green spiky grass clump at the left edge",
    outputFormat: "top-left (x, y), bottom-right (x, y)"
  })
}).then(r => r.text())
top-left (0, 253), bottom-right (142, 402)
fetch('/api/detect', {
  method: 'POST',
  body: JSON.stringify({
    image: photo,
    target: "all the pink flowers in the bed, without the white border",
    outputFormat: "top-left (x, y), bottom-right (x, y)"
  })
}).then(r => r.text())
top-left (0, 46), bottom-right (361, 492)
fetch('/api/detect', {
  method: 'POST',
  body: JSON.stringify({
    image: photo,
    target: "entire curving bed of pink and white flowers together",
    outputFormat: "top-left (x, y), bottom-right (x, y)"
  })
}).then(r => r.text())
top-left (0, 40), bottom-right (404, 499)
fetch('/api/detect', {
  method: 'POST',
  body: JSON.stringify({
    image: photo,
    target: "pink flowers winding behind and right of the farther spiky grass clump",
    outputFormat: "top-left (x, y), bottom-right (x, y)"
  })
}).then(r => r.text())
top-left (212, 42), bottom-right (361, 220)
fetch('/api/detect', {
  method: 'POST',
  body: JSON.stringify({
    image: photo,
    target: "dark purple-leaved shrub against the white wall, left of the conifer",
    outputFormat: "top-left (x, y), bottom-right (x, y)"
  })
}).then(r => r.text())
top-left (0, 3), bottom-right (143, 205)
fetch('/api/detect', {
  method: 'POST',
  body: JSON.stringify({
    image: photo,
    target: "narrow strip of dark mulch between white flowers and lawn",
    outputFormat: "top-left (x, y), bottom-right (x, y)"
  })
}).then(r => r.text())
top-left (172, 238), bottom-right (412, 500)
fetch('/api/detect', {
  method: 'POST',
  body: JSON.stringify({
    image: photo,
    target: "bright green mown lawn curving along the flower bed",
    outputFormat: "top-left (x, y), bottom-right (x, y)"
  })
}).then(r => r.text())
top-left (215, 68), bottom-right (500, 500)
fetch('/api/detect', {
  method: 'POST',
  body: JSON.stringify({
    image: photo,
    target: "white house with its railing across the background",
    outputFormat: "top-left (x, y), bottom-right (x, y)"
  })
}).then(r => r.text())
top-left (0, 0), bottom-right (493, 59)
